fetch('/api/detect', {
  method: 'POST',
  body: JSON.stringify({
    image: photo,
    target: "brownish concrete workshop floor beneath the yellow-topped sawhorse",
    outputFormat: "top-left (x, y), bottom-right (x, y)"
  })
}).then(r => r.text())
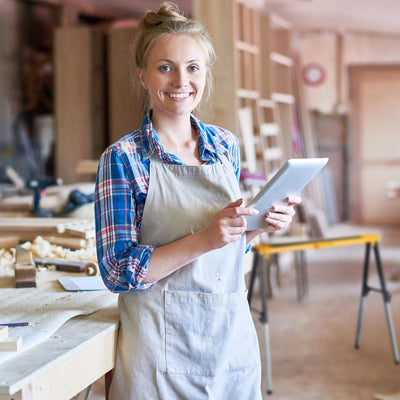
top-left (88, 226), bottom-right (400, 400)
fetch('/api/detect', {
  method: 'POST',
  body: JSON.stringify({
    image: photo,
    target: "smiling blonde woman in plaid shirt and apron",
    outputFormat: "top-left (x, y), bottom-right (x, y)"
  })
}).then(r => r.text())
top-left (95, 3), bottom-right (300, 400)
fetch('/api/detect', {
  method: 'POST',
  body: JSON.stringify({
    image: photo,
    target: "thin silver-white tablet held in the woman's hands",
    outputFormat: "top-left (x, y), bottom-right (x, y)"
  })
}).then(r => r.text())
top-left (245, 158), bottom-right (328, 231)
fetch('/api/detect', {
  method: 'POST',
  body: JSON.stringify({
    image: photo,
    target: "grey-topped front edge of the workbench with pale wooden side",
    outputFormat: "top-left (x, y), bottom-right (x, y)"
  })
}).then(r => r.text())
top-left (0, 308), bottom-right (119, 400)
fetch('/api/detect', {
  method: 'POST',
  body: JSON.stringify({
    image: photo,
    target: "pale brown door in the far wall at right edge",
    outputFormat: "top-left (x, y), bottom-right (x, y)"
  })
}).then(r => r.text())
top-left (349, 66), bottom-right (400, 225)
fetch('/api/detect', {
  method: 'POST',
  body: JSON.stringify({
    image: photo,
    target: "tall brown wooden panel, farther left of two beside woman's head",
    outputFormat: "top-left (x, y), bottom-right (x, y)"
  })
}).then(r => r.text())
top-left (54, 27), bottom-right (105, 183)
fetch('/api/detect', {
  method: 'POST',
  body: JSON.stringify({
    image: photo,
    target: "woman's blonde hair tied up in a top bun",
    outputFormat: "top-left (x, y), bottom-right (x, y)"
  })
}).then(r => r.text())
top-left (134, 2), bottom-right (216, 114)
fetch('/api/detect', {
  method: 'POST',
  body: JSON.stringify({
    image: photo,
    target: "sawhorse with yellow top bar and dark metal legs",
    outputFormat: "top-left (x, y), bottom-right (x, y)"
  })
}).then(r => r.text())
top-left (248, 234), bottom-right (400, 394)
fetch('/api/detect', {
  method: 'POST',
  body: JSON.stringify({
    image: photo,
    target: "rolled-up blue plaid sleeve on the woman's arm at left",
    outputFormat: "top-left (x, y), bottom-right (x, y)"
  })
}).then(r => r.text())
top-left (94, 147), bottom-right (154, 293)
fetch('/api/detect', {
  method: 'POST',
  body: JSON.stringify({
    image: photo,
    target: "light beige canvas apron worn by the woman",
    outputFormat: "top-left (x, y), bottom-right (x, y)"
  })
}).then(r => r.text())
top-left (110, 156), bottom-right (261, 400)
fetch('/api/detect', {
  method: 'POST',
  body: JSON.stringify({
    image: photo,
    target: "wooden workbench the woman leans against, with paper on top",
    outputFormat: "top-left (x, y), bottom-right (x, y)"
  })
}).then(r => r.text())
top-left (0, 272), bottom-right (119, 400)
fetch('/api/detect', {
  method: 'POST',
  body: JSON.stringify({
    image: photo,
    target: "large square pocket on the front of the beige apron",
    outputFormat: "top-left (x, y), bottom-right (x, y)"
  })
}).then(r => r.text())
top-left (165, 291), bottom-right (259, 376)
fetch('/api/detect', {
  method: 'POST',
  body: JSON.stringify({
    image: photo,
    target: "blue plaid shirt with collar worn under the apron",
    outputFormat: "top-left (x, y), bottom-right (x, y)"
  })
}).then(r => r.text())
top-left (95, 115), bottom-right (240, 293)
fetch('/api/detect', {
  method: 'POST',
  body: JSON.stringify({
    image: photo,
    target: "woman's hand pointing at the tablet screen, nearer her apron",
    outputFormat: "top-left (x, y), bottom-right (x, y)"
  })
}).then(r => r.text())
top-left (201, 199), bottom-right (258, 249)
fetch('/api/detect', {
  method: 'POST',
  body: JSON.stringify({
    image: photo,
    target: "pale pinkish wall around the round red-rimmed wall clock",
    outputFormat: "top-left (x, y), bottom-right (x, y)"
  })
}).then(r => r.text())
top-left (294, 31), bottom-right (400, 114)
